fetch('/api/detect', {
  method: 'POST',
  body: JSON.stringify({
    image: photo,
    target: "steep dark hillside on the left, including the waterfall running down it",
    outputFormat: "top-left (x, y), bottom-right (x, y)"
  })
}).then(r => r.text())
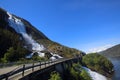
top-left (0, 8), bottom-right (85, 61)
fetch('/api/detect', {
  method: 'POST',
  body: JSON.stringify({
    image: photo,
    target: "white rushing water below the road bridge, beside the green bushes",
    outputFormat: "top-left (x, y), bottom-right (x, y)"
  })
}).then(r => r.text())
top-left (83, 67), bottom-right (107, 80)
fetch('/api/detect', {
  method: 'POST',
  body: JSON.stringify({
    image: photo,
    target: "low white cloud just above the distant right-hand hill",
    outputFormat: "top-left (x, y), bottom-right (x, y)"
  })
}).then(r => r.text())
top-left (87, 44), bottom-right (113, 53)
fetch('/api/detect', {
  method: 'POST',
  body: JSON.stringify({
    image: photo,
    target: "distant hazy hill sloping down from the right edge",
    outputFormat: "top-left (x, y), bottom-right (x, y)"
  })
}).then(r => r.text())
top-left (100, 44), bottom-right (120, 57)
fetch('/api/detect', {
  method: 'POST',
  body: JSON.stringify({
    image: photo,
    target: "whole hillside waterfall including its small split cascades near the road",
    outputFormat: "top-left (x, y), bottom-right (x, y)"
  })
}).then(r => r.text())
top-left (7, 12), bottom-right (62, 59)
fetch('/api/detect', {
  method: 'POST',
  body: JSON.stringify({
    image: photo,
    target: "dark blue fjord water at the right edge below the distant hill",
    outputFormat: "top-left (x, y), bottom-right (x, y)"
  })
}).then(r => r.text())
top-left (109, 57), bottom-right (120, 80)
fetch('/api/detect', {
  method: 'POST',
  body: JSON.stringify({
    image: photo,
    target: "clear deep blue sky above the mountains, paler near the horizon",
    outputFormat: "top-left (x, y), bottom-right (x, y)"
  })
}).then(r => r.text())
top-left (0, 0), bottom-right (120, 52)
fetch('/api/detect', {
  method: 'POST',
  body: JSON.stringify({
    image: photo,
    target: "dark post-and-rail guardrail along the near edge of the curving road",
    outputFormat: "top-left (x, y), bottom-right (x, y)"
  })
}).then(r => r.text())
top-left (0, 58), bottom-right (80, 80)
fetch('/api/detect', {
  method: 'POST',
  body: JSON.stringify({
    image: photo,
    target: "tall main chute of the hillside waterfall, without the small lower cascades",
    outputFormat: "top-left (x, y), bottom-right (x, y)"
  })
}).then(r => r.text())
top-left (7, 12), bottom-right (45, 52)
